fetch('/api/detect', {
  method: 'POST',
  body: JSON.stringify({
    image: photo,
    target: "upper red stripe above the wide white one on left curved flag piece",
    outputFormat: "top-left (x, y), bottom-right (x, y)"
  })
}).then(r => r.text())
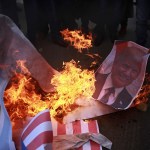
top-left (22, 112), bottom-right (50, 140)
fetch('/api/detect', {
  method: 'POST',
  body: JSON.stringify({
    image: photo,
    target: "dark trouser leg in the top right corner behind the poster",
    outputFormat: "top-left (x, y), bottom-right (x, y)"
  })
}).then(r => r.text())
top-left (136, 0), bottom-right (150, 46)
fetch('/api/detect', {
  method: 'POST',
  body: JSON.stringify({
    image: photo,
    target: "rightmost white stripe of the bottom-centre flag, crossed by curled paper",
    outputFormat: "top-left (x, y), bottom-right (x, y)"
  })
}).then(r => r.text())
top-left (81, 120), bottom-right (91, 150)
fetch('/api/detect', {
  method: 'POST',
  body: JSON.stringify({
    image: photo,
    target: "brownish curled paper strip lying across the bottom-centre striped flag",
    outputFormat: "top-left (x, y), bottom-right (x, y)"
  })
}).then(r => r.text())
top-left (53, 133), bottom-right (112, 150)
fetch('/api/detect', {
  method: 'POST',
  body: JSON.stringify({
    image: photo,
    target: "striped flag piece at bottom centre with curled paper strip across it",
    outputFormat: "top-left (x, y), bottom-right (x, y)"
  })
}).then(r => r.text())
top-left (52, 119), bottom-right (112, 150)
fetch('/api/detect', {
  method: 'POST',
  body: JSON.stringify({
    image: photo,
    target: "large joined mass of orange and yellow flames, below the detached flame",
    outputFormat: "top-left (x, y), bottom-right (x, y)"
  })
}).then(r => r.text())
top-left (4, 61), bottom-right (95, 122)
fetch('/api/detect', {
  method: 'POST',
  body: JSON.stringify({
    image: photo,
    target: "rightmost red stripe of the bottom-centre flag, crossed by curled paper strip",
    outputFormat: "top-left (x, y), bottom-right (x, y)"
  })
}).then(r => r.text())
top-left (88, 120), bottom-right (100, 150)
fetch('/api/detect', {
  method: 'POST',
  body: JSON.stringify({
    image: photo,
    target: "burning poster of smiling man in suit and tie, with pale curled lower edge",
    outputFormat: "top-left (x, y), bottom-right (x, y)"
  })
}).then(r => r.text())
top-left (64, 41), bottom-right (149, 122)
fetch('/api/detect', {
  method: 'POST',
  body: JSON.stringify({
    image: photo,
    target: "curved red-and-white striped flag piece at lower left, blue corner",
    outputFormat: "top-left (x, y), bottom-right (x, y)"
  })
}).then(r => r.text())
top-left (21, 110), bottom-right (53, 150)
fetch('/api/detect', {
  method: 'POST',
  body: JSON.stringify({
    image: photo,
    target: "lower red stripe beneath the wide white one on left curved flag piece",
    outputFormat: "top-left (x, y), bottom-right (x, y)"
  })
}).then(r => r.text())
top-left (27, 131), bottom-right (53, 150)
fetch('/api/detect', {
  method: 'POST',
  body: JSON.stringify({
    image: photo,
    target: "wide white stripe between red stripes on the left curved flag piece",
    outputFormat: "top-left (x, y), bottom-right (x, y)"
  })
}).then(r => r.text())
top-left (23, 121), bottom-right (52, 146)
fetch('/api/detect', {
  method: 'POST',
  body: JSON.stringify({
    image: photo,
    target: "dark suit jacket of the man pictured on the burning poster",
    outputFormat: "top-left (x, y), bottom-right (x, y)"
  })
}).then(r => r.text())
top-left (93, 73), bottom-right (133, 109)
